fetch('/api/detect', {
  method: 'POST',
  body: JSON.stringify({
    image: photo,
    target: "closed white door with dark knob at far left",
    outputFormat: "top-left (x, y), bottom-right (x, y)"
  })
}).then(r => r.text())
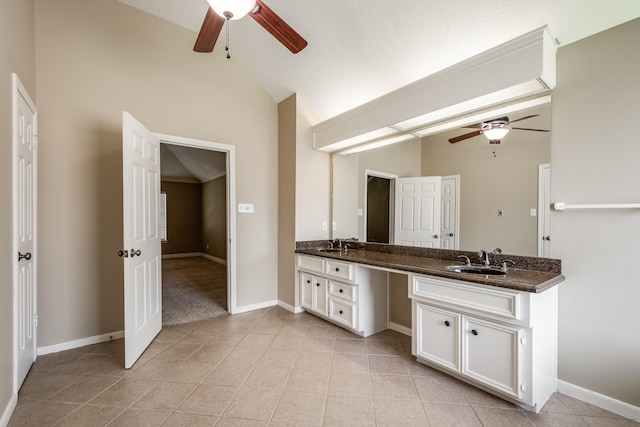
top-left (13, 74), bottom-right (38, 391)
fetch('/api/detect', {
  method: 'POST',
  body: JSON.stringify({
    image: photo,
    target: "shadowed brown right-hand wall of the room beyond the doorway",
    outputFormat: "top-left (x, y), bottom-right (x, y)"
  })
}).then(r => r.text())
top-left (201, 175), bottom-right (227, 260)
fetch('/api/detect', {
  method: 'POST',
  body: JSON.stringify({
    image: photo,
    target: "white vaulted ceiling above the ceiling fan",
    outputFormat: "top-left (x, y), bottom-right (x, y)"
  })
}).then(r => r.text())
top-left (119, 0), bottom-right (640, 124)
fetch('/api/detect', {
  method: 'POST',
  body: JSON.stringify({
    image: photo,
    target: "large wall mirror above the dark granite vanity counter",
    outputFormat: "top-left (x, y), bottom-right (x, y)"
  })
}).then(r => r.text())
top-left (332, 104), bottom-right (551, 256)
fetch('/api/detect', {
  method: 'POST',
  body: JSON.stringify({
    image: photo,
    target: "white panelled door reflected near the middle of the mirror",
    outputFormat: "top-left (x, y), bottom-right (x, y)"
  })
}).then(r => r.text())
top-left (394, 176), bottom-right (441, 248)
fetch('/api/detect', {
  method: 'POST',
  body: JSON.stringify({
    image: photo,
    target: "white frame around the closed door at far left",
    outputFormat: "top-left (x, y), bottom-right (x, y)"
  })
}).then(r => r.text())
top-left (11, 73), bottom-right (38, 393)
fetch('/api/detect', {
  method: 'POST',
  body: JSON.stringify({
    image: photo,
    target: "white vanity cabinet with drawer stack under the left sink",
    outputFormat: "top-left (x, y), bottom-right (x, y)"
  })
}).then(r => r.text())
top-left (296, 255), bottom-right (389, 337)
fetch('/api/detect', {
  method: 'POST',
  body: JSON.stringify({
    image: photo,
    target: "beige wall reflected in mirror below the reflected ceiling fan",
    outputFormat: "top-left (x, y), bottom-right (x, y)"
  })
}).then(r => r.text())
top-left (422, 122), bottom-right (551, 256)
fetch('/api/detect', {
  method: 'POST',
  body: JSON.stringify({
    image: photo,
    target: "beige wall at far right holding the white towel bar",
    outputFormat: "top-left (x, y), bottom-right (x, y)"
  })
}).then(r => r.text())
top-left (551, 20), bottom-right (640, 406)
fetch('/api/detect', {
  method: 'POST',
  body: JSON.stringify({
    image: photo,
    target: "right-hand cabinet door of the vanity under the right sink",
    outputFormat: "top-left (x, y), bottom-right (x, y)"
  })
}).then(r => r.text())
top-left (461, 317), bottom-right (523, 398)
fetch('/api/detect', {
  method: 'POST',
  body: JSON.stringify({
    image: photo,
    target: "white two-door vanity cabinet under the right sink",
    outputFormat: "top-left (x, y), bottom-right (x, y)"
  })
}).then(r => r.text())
top-left (409, 275), bottom-right (557, 411)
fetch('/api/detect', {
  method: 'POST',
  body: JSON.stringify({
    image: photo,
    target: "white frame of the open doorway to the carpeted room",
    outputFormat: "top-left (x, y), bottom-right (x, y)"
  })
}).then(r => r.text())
top-left (154, 133), bottom-right (237, 314)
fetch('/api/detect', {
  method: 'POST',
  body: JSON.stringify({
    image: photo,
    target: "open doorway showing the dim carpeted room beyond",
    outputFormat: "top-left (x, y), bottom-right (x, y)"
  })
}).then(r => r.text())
top-left (160, 142), bottom-right (228, 326)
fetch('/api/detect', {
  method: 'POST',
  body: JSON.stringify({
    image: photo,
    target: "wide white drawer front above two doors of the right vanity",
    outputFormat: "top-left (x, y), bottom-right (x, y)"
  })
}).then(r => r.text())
top-left (411, 276), bottom-right (522, 320)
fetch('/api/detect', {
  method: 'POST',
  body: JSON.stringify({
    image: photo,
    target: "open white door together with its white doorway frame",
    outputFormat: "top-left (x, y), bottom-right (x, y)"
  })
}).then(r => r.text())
top-left (119, 111), bottom-right (236, 369)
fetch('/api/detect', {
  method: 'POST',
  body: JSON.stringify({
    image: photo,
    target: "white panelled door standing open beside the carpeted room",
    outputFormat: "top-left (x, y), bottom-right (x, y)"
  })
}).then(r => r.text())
top-left (122, 112), bottom-right (162, 368)
